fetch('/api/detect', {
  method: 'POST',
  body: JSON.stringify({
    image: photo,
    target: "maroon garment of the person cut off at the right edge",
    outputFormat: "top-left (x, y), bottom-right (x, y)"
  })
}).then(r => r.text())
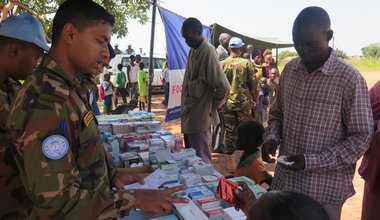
top-left (359, 81), bottom-right (380, 220)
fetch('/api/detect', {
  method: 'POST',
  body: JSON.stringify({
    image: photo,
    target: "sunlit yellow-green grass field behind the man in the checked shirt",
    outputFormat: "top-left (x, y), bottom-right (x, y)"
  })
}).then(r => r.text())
top-left (278, 58), bottom-right (380, 74)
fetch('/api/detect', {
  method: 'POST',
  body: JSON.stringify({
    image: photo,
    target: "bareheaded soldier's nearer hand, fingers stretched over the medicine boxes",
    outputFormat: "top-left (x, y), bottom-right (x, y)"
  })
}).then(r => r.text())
top-left (135, 186), bottom-right (189, 216)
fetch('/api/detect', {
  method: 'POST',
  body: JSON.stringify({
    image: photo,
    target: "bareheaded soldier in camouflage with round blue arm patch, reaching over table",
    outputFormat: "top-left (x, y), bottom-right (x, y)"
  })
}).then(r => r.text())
top-left (7, 0), bottom-right (188, 219)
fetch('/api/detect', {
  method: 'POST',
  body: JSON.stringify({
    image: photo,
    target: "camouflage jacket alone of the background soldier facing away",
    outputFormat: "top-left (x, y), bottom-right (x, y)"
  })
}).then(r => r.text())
top-left (220, 56), bottom-right (258, 115)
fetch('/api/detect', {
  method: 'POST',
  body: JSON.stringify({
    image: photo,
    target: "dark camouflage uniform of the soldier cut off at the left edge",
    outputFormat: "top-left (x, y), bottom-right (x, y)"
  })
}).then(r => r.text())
top-left (0, 78), bottom-right (31, 219)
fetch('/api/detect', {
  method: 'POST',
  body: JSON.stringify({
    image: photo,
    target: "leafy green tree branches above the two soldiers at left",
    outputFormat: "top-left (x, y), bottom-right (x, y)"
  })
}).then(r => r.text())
top-left (0, 0), bottom-right (152, 39)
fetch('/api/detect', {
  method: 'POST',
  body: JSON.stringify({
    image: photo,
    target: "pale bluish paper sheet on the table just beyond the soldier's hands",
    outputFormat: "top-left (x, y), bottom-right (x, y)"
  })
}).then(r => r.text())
top-left (124, 169), bottom-right (167, 189)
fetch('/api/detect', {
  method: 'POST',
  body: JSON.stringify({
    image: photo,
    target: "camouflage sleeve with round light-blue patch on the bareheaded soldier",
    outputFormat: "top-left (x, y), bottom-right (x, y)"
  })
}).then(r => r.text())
top-left (8, 80), bottom-right (135, 219)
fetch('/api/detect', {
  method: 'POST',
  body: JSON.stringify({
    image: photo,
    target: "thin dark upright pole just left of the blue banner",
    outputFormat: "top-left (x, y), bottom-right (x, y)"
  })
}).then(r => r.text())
top-left (148, 0), bottom-right (157, 112)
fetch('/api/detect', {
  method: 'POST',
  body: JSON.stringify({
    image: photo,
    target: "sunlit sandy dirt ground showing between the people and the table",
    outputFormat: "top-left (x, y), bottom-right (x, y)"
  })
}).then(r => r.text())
top-left (144, 70), bottom-right (380, 220)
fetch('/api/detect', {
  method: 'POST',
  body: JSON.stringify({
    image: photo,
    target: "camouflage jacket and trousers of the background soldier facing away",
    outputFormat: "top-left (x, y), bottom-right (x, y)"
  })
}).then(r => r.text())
top-left (220, 56), bottom-right (258, 154)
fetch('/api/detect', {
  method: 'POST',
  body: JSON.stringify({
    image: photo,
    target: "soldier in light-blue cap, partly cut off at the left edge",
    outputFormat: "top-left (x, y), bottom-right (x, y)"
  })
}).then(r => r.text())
top-left (0, 13), bottom-right (49, 219)
